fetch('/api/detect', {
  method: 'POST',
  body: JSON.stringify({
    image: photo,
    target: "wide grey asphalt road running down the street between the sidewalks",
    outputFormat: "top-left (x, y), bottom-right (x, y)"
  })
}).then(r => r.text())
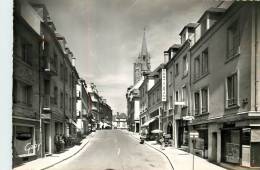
top-left (50, 130), bottom-right (172, 170)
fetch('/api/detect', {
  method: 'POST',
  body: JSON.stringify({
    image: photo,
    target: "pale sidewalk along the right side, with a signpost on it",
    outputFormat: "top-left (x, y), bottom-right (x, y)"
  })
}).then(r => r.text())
top-left (128, 132), bottom-right (225, 170)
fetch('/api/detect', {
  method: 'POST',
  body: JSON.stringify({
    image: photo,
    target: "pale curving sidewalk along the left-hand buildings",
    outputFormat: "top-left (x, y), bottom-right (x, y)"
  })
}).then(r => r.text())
top-left (13, 133), bottom-right (94, 170)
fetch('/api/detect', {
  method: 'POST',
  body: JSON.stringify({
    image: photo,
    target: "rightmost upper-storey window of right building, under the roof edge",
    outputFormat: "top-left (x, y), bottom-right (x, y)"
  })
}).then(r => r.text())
top-left (227, 21), bottom-right (240, 58)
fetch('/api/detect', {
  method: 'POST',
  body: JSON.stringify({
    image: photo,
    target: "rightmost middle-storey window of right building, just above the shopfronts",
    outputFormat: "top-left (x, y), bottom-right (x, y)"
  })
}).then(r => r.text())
top-left (226, 73), bottom-right (238, 107)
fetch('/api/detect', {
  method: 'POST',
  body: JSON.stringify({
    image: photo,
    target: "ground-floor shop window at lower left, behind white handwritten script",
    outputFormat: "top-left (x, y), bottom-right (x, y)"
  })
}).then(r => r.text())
top-left (13, 126), bottom-right (35, 157)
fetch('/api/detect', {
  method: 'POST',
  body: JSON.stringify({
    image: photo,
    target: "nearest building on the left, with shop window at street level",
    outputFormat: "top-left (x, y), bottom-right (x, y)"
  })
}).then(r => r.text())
top-left (12, 1), bottom-right (42, 166)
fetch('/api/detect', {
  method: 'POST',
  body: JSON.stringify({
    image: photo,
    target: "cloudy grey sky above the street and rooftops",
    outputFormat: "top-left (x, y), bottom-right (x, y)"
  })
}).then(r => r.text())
top-left (33, 0), bottom-right (220, 113)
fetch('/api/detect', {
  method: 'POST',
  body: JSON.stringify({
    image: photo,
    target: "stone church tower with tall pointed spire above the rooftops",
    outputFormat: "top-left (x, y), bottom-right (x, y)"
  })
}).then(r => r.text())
top-left (134, 29), bottom-right (151, 84)
